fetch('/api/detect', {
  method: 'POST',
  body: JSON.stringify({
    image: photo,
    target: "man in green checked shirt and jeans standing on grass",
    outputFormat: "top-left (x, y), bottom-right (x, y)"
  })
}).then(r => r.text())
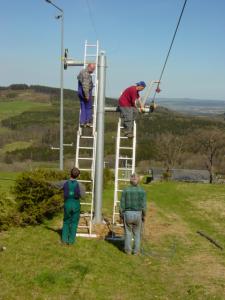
top-left (120, 174), bottom-right (146, 255)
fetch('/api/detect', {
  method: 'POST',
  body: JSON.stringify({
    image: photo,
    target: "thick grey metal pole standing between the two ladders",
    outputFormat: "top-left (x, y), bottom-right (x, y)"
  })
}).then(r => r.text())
top-left (94, 52), bottom-right (106, 224)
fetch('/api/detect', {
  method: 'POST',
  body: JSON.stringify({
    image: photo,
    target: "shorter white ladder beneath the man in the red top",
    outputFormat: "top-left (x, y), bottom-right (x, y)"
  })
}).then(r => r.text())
top-left (112, 119), bottom-right (136, 238)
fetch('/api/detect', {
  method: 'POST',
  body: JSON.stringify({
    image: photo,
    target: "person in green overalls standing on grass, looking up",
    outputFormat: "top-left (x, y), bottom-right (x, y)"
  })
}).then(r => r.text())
top-left (62, 168), bottom-right (85, 245)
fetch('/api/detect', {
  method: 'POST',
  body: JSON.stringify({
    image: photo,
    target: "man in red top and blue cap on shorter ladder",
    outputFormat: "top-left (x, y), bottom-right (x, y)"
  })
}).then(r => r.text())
top-left (119, 81), bottom-right (146, 138)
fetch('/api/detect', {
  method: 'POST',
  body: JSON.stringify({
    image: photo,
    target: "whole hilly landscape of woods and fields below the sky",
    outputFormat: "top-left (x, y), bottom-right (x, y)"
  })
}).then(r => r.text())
top-left (0, 84), bottom-right (225, 172)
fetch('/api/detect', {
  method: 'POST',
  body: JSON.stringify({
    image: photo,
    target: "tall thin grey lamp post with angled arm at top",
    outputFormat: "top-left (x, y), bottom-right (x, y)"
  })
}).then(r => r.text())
top-left (45, 0), bottom-right (64, 170)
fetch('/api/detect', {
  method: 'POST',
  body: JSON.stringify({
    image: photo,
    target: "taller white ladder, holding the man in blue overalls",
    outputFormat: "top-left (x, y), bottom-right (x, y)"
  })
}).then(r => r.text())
top-left (75, 41), bottom-right (99, 237)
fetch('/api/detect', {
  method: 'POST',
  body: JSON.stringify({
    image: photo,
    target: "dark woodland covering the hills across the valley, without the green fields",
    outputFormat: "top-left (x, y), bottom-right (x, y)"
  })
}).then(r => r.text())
top-left (0, 84), bottom-right (225, 180)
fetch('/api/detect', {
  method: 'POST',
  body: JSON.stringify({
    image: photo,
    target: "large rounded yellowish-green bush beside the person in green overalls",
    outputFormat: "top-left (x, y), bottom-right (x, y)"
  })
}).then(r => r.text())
top-left (14, 169), bottom-right (68, 225)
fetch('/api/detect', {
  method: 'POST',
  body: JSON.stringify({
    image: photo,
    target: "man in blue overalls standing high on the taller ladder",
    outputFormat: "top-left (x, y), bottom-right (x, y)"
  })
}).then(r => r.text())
top-left (77, 64), bottom-right (95, 127)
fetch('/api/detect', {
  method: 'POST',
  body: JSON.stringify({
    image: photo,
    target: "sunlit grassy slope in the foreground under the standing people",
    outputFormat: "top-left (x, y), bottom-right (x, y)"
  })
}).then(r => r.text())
top-left (0, 182), bottom-right (225, 300)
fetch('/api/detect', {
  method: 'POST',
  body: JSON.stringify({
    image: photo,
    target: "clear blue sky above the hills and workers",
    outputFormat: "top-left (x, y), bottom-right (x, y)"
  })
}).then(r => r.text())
top-left (0, 0), bottom-right (225, 100)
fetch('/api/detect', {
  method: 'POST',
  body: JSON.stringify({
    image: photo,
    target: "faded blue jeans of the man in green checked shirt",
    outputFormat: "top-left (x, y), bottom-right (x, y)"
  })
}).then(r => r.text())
top-left (124, 211), bottom-right (142, 253)
